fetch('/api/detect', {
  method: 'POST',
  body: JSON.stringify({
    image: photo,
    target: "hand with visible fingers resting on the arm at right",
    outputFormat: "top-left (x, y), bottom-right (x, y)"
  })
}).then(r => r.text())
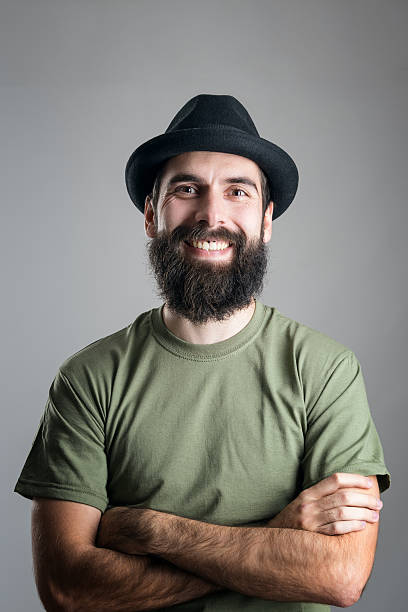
top-left (266, 472), bottom-right (380, 535)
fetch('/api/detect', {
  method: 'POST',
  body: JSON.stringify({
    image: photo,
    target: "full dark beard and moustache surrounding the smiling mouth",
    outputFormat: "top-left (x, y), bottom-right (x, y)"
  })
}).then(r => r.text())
top-left (147, 223), bottom-right (268, 324)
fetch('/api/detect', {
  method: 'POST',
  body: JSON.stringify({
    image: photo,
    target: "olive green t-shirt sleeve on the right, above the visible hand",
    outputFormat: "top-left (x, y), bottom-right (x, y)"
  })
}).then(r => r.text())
top-left (301, 350), bottom-right (391, 492)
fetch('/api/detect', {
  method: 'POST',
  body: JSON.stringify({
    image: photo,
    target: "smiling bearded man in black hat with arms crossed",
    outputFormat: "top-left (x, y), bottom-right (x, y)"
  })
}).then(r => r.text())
top-left (15, 94), bottom-right (390, 611)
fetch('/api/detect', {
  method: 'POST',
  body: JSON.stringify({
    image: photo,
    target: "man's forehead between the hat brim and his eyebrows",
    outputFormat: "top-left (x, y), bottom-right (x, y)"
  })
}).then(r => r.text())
top-left (163, 151), bottom-right (260, 183)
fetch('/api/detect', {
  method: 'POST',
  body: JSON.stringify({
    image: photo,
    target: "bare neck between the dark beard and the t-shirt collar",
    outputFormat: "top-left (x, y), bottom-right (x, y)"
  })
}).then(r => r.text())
top-left (162, 298), bottom-right (255, 344)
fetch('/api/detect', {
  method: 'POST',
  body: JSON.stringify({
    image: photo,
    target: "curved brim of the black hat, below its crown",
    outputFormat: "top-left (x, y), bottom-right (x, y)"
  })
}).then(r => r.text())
top-left (125, 127), bottom-right (299, 219)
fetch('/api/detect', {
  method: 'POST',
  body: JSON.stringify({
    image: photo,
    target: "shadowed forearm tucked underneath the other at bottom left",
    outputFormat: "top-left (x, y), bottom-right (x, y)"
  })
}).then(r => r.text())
top-left (53, 547), bottom-right (223, 612)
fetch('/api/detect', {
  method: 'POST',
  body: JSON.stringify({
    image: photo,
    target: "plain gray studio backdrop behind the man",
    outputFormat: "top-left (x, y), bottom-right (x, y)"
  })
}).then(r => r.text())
top-left (0, 0), bottom-right (408, 612)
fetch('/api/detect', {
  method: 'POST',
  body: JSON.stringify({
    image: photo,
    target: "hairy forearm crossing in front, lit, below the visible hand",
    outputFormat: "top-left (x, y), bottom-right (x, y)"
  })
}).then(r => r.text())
top-left (151, 513), bottom-right (344, 605)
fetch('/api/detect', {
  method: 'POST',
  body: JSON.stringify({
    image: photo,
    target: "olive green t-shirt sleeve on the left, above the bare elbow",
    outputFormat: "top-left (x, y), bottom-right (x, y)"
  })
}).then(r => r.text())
top-left (14, 368), bottom-right (108, 513)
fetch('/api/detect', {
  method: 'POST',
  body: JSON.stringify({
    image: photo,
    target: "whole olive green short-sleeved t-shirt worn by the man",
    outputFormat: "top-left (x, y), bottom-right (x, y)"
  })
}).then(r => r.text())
top-left (14, 300), bottom-right (390, 612)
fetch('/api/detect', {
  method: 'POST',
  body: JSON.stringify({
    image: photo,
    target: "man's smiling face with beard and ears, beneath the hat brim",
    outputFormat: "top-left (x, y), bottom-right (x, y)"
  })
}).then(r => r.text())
top-left (145, 151), bottom-right (273, 323)
